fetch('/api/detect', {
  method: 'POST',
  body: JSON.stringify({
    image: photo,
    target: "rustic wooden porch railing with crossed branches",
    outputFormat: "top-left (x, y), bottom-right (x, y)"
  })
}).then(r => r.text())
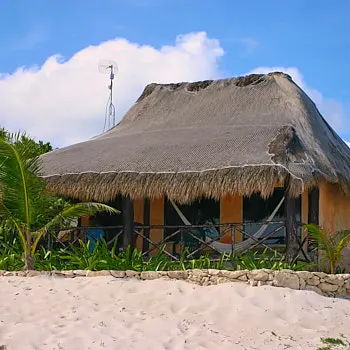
top-left (47, 221), bottom-right (314, 260)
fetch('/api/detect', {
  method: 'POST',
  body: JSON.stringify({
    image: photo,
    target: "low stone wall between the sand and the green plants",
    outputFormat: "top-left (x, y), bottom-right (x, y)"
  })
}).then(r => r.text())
top-left (0, 269), bottom-right (350, 297)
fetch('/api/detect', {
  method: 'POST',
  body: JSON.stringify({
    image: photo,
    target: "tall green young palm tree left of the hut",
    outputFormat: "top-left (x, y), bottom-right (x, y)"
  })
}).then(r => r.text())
top-left (0, 134), bottom-right (118, 270)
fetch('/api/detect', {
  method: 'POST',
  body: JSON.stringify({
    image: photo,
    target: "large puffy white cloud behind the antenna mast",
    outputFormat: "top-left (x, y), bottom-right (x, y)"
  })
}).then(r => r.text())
top-left (0, 32), bottom-right (224, 146)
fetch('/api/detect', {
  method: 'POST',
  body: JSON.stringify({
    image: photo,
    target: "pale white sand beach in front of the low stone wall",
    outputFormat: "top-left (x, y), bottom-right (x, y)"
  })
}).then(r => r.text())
top-left (0, 277), bottom-right (350, 350)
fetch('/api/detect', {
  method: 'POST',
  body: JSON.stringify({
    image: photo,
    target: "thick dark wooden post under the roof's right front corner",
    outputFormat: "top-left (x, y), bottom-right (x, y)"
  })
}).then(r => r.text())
top-left (284, 183), bottom-right (299, 262)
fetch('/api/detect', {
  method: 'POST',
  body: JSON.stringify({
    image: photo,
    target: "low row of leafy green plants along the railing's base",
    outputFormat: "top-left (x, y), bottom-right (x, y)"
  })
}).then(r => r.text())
top-left (0, 237), bottom-right (307, 272)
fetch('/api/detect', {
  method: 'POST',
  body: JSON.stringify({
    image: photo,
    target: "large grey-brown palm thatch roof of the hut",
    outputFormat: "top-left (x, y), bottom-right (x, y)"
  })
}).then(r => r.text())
top-left (42, 72), bottom-right (350, 202)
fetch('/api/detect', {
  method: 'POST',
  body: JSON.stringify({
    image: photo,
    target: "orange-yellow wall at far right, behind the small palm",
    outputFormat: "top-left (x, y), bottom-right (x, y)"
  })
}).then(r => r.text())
top-left (319, 183), bottom-right (350, 271)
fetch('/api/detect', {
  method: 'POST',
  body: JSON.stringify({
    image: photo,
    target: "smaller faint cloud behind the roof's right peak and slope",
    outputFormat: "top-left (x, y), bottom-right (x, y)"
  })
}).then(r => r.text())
top-left (249, 67), bottom-right (345, 132)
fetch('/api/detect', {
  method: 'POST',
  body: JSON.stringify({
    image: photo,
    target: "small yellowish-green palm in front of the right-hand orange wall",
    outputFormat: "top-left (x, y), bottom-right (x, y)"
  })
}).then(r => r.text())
top-left (305, 224), bottom-right (350, 274)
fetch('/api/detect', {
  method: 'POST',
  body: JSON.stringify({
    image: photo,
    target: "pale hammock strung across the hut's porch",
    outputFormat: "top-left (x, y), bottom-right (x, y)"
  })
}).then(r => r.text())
top-left (170, 197), bottom-right (284, 253)
